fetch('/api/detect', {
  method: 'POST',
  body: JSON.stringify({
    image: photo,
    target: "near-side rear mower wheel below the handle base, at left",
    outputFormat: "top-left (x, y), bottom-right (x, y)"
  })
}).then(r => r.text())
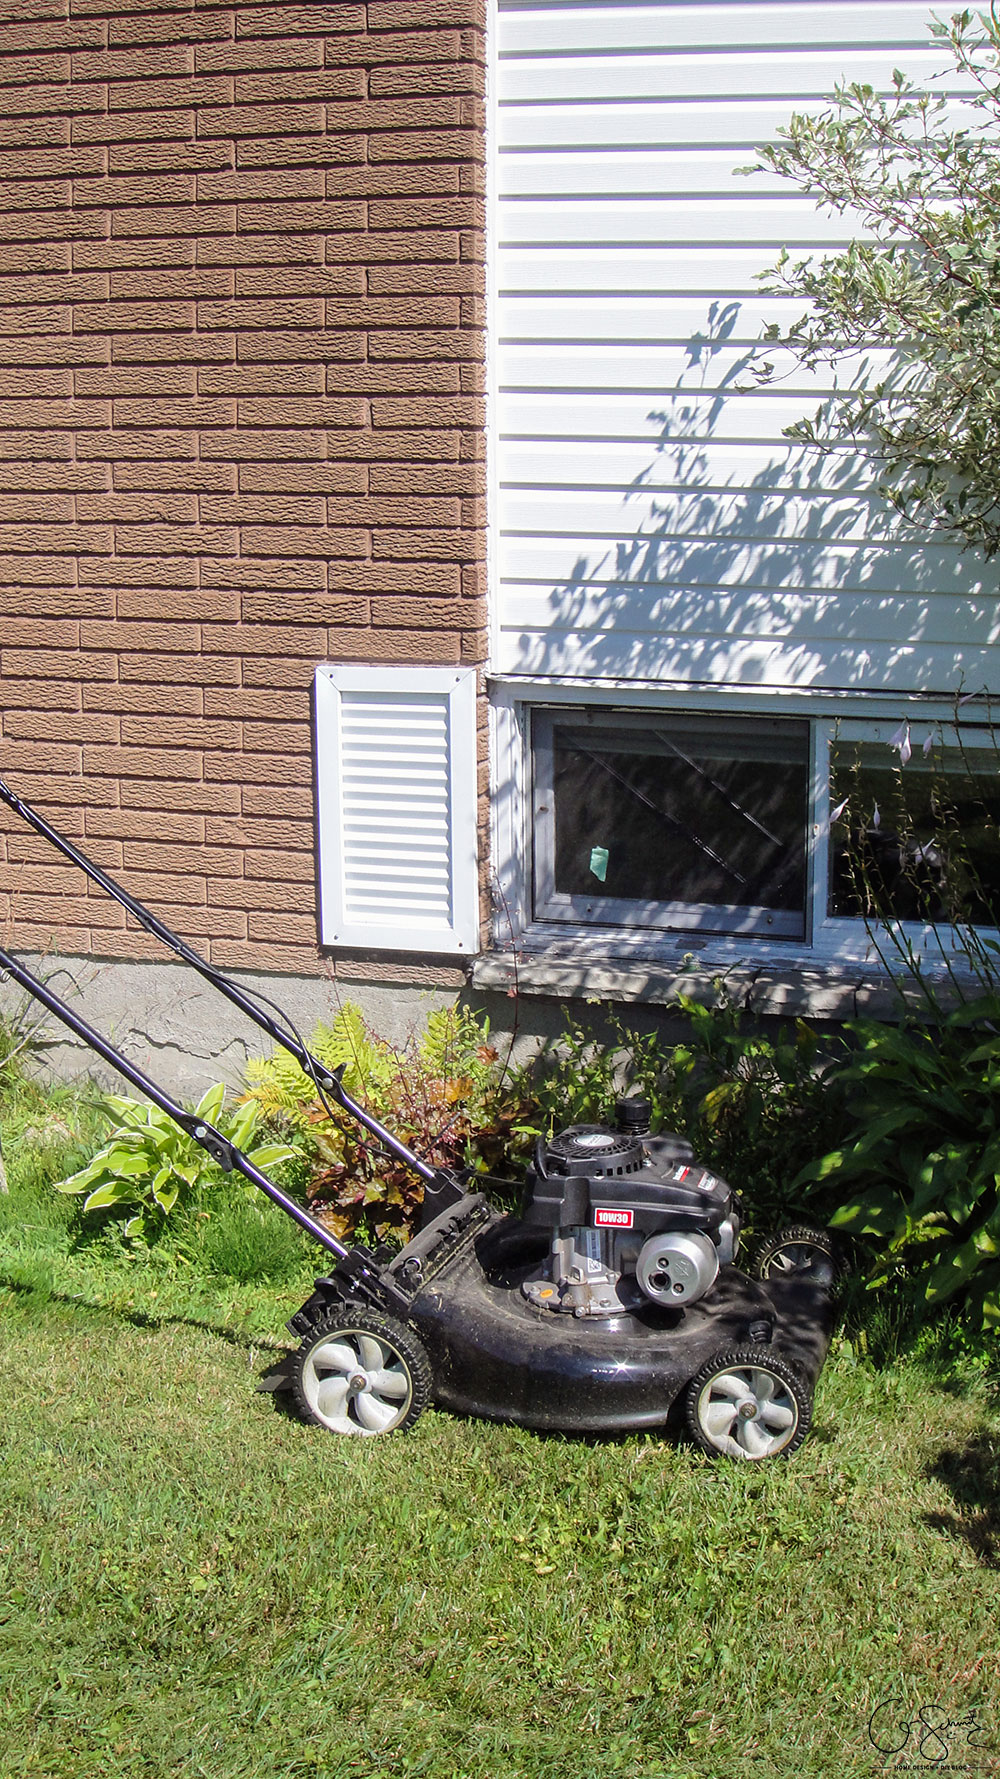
top-left (290, 1304), bottom-right (432, 1437)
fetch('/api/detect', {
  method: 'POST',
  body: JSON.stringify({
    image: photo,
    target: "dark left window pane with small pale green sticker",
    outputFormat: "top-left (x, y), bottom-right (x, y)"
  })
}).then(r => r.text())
top-left (540, 717), bottom-right (808, 927)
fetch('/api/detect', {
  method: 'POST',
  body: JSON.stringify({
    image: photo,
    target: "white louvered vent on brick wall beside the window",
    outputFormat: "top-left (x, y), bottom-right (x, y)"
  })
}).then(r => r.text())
top-left (317, 667), bottom-right (479, 952)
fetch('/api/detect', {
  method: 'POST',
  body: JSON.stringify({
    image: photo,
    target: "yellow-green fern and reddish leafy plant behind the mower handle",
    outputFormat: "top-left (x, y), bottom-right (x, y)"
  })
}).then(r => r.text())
top-left (246, 1002), bottom-right (516, 1240)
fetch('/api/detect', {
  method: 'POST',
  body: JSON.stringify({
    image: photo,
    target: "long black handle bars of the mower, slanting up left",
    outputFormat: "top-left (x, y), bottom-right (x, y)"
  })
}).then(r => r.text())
top-left (0, 777), bottom-right (457, 1202)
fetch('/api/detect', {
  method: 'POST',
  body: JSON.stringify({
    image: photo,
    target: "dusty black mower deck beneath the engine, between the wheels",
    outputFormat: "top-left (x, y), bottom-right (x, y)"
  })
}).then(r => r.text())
top-left (274, 1194), bottom-right (835, 1434)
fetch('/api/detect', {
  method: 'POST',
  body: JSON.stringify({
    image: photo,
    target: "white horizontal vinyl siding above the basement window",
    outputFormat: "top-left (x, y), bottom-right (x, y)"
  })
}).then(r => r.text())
top-left (495, 0), bottom-right (1000, 696)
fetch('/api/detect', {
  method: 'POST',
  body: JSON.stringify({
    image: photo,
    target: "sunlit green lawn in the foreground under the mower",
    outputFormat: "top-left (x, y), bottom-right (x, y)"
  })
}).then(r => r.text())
top-left (0, 1095), bottom-right (1000, 1779)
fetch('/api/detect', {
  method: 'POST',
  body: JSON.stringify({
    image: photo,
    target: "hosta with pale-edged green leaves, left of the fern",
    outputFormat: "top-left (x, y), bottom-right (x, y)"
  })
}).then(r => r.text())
top-left (55, 1082), bottom-right (299, 1236)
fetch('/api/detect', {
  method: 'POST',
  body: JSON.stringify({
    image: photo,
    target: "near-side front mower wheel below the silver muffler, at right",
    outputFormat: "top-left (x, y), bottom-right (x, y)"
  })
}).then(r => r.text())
top-left (685, 1345), bottom-right (811, 1462)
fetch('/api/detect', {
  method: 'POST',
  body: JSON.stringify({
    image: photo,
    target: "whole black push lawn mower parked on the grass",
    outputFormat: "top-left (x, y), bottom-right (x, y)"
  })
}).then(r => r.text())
top-left (0, 779), bottom-right (836, 1461)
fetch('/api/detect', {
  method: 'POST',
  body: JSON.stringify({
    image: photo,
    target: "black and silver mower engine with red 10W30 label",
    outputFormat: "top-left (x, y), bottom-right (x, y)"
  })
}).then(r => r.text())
top-left (521, 1098), bottom-right (740, 1316)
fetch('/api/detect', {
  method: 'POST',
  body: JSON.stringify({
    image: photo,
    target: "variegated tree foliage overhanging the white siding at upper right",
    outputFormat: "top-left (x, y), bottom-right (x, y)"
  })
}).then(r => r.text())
top-left (747, 11), bottom-right (1000, 557)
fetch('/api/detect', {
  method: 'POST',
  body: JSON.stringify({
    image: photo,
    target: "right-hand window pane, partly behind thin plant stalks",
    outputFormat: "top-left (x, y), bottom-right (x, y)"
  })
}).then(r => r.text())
top-left (829, 731), bottom-right (1000, 927)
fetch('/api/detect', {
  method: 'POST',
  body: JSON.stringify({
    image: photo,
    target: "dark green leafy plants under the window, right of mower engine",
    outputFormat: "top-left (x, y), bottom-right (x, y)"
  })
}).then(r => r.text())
top-left (521, 987), bottom-right (1000, 1327)
